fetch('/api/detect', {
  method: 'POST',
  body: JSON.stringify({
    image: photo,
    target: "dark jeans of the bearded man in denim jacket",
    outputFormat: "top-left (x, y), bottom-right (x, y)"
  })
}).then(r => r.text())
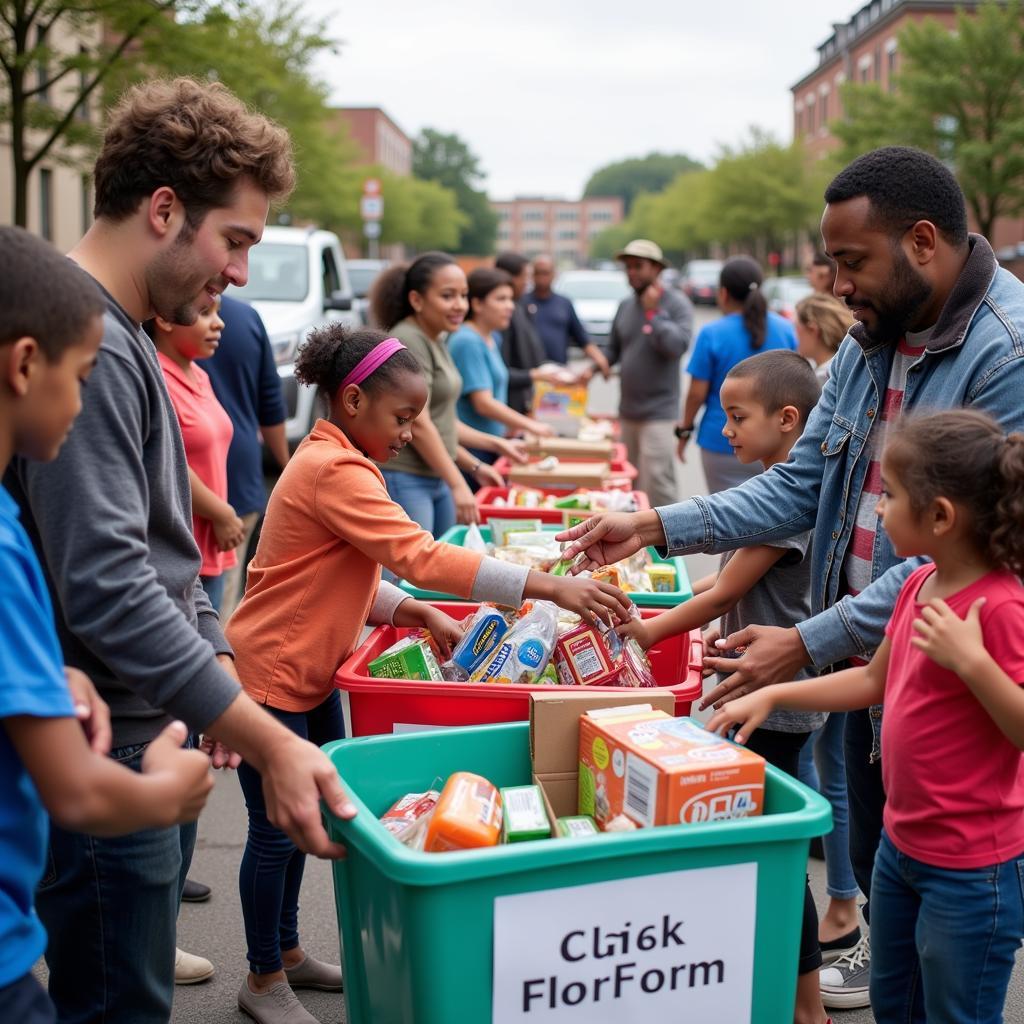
top-left (844, 710), bottom-right (886, 923)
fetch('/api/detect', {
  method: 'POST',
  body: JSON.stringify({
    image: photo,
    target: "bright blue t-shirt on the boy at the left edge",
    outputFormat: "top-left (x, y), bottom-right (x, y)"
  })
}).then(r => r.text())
top-left (0, 487), bottom-right (74, 988)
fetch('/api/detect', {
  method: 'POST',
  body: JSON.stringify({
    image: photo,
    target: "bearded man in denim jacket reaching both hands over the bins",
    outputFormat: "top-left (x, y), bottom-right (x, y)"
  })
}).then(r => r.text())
top-left (563, 146), bottom-right (1024, 1007)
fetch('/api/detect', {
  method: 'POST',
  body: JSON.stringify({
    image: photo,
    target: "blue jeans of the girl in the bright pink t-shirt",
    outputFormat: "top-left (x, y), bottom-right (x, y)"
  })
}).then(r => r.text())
top-left (871, 833), bottom-right (1024, 1024)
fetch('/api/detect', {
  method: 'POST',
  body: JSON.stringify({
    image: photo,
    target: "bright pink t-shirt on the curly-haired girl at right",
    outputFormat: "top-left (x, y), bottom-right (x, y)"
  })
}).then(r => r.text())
top-left (882, 563), bottom-right (1024, 869)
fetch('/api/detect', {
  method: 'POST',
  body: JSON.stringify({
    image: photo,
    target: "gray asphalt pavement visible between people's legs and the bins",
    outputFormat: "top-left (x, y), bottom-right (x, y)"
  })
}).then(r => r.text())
top-left (165, 308), bottom-right (1024, 1024)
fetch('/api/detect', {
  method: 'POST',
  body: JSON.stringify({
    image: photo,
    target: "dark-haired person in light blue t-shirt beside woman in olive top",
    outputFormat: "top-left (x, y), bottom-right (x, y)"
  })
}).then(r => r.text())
top-left (447, 267), bottom-right (554, 490)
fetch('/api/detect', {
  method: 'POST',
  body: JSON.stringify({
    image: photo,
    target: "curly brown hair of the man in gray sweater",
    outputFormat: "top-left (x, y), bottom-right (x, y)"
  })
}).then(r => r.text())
top-left (94, 78), bottom-right (295, 227)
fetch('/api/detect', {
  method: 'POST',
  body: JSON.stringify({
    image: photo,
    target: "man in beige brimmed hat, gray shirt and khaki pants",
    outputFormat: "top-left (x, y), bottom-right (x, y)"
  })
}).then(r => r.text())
top-left (608, 239), bottom-right (693, 508)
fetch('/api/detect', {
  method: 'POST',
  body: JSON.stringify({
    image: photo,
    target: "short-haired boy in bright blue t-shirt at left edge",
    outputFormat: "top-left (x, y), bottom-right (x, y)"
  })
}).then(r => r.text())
top-left (0, 227), bottom-right (213, 1024)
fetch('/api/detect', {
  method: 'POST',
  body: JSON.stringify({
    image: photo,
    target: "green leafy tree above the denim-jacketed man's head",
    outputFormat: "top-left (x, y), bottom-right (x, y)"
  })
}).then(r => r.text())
top-left (830, 0), bottom-right (1024, 237)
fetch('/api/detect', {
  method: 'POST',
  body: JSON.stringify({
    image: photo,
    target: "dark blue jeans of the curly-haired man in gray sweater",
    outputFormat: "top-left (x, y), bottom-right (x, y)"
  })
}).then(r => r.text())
top-left (36, 743), bottom-right (196, 1024)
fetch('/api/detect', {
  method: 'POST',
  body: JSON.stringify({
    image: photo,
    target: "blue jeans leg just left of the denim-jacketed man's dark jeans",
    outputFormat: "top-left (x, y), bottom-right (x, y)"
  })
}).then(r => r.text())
top-left (800, 712), bottom-right (860, 899)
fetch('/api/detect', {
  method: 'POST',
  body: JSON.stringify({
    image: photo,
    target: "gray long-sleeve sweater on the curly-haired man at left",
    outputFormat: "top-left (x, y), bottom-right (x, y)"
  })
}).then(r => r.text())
top-left (5, 286), bottom-right (239, 748)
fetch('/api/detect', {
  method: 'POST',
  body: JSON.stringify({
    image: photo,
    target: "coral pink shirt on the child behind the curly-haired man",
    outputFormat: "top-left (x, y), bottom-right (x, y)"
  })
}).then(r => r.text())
top-left (157, 352), bottom-right (237, 575)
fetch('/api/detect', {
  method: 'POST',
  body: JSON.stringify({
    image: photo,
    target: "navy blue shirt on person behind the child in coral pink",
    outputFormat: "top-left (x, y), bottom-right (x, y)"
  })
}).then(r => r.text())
top-left (200, 295), bottom-right (288, 515)
